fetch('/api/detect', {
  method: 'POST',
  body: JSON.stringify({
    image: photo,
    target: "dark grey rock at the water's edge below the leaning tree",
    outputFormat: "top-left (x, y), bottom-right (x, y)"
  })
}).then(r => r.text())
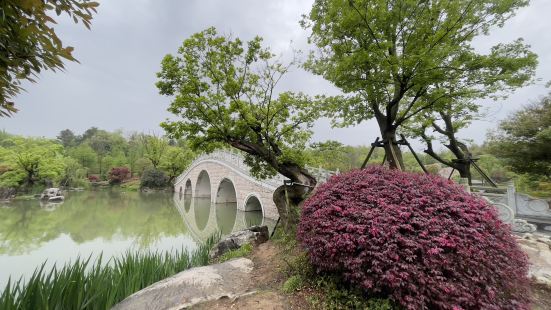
top-left (209, 225), bottom-right (270, 259)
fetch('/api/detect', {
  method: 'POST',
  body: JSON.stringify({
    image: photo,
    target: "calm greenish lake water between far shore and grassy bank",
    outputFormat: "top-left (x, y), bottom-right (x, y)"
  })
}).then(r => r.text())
top-left (0, 191), bottom-right (275, 291)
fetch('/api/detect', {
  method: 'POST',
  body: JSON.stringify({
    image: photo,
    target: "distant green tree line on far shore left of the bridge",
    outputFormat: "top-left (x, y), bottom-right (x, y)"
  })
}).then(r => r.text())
top-left (0, 127), bottom-right (195, 191)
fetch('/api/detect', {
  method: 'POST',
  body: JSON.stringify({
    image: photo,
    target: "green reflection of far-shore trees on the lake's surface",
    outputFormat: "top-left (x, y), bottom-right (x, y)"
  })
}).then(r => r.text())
top-left (0, 191), bottom-right (186, 254)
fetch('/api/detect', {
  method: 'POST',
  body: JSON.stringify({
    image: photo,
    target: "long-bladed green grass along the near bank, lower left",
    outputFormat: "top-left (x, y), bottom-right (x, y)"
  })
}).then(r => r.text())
top-left (0, 237), bottom-right (218, 310)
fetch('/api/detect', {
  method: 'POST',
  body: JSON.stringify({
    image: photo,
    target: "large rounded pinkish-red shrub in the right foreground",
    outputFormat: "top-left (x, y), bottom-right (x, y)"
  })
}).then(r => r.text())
top-left (298, 167), bottom-right (529, 310)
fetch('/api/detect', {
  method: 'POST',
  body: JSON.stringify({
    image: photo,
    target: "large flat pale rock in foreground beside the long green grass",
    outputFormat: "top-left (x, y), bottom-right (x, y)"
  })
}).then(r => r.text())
top-left (112, 258), bottom-right (254, 310)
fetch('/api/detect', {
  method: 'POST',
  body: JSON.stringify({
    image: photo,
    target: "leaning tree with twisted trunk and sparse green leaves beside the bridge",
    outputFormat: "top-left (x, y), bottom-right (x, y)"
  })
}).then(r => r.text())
top-left (157, 28), bottom-right (319, 229)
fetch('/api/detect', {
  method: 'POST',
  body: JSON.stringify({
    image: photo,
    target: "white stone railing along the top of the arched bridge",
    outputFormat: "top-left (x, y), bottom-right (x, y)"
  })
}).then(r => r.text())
top-left (175, 150), bottom-right (339, 187)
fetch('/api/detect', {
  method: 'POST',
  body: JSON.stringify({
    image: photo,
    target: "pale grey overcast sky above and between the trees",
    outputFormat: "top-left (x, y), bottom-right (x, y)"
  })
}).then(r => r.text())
top-left (0, 0), bottom-right (551, 150)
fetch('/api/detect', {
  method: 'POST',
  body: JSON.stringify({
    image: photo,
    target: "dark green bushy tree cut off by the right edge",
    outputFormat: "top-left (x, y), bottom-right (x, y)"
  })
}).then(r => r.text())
top-left (488, 94), bottom-right (551, 178)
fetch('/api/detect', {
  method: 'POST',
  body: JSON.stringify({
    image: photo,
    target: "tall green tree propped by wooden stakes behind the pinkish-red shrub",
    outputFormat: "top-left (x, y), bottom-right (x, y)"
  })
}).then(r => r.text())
top-left (302, 0), bottom-right (528, 168)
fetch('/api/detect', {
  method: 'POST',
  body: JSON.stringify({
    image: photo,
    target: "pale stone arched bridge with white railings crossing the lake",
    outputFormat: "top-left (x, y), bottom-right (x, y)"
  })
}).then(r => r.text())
top-left (174, 151), bottom-right (335, 228)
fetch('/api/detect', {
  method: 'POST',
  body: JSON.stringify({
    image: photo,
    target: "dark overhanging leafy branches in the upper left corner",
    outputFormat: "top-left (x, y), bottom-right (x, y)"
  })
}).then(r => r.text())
top-left (0, 0), bottom-right (99, 117)
